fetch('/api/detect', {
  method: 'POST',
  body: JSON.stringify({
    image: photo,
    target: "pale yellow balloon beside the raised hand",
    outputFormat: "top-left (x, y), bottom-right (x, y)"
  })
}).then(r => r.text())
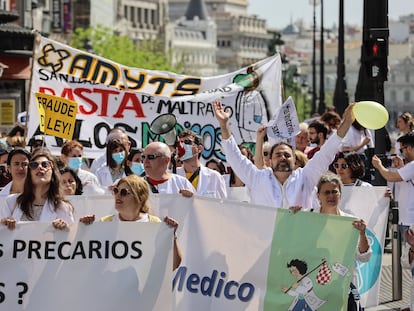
top-left (353, 101), bottom-right (389, 130)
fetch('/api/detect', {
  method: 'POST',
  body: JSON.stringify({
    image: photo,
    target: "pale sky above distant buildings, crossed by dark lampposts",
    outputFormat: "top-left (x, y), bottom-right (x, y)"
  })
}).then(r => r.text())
top-left (248, 0), bottom-right (414, 29)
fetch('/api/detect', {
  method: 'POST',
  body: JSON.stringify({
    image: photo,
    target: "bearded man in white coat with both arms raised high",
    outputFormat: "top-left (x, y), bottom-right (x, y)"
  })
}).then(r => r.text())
top-left (213, 101), bottom-right (355, 211)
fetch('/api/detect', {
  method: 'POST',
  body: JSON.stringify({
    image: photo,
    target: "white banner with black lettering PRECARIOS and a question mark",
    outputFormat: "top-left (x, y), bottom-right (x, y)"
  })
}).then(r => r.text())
top-left (0, 222), bottom-right (173, 311)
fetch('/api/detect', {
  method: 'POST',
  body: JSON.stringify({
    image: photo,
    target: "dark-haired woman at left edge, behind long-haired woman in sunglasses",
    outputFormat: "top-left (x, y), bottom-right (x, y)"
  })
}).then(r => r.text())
top-left (0, 148), bottom-right (31, 196)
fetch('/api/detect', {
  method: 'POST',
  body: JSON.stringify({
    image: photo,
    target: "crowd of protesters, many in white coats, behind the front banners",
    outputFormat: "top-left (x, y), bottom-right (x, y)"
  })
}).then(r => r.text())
top-left (0, 38), bottom-right (414, 310)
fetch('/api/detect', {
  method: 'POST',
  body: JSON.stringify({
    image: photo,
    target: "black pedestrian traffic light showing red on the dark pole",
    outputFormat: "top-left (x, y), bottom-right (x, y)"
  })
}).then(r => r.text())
top-left (363, 29), bottom-right (388, 81)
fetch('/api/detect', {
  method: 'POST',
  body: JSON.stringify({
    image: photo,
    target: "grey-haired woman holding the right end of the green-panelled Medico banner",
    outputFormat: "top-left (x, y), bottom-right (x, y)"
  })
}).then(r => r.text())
top-left (317, 172), bottom-right (372, 310)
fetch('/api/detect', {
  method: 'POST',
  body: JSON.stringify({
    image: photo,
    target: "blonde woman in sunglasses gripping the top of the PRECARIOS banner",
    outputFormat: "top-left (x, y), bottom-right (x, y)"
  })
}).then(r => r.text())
top-left (79, 174), bottom-right (182, 270)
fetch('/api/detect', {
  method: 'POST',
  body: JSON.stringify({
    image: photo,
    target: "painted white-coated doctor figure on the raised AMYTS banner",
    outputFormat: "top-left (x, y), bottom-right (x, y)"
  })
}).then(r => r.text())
top-left (233, 67), bottom-right (267, 142)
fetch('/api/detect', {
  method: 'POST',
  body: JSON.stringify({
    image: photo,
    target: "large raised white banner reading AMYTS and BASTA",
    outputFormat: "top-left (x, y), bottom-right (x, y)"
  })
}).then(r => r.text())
top-left (28, 37), bottom-right (281, 159)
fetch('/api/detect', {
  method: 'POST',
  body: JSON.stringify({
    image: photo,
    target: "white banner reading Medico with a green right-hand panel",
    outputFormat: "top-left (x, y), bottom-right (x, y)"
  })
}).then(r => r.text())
top-left (68, 195), bottom-right (358, 311)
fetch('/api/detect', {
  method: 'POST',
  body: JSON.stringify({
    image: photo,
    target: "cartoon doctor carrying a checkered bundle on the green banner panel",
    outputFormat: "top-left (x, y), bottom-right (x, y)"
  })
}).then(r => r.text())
top-left (283, 259), bottom-right (326, 311)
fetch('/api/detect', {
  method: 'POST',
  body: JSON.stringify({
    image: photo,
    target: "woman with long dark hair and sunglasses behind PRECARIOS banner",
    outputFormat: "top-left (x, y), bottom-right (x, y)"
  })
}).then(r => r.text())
top-left (0, 151), bottom-right (74, 229)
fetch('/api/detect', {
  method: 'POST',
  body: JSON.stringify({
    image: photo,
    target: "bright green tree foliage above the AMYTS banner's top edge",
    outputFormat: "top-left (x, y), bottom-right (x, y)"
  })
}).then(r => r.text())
top-left (70, 25), bottom-right (183, 73)
